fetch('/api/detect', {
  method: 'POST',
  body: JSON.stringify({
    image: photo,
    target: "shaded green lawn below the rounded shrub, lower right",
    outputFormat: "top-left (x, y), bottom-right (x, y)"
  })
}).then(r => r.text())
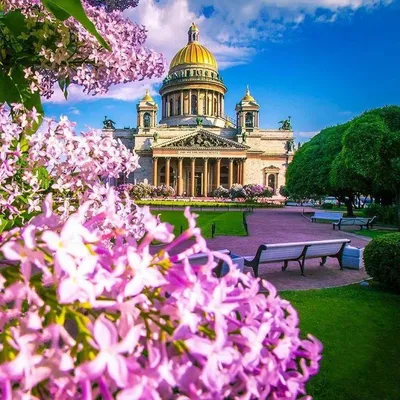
top-left (281, 285), bottom-right (400, 400)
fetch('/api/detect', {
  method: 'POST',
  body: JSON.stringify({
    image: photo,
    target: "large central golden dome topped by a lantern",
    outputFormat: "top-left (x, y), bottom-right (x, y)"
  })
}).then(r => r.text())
top-left (170, 22), bottom-right (218, 70)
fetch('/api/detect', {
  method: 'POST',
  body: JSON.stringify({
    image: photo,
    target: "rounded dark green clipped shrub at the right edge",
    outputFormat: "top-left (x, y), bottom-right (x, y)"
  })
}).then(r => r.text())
top-left (364, 233), bottom-right (400, 292)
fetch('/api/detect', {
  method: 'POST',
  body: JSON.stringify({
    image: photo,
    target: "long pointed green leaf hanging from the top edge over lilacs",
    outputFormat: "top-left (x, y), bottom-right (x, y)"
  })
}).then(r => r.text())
top-left (42, 0), bottom-right (111, 50)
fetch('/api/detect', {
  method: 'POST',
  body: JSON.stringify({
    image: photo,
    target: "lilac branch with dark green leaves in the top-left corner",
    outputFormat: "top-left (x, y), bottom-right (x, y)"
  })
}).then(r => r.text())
top-left (0, 0), bottom-right (165, 111)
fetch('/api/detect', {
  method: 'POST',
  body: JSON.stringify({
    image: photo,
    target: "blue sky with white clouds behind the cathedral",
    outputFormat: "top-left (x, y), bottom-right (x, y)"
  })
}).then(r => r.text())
top-left (45, 0), bottom-right (400, 141)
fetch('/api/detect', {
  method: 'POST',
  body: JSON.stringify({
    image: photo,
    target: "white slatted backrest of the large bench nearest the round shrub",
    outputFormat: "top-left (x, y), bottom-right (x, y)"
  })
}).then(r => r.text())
top-left (259, 239), bottom-right (350, 263)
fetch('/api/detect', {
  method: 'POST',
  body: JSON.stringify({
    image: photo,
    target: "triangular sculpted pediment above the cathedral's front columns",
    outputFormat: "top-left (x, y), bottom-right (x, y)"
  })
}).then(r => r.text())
top-left (153, 129), bottom-right (249, 150)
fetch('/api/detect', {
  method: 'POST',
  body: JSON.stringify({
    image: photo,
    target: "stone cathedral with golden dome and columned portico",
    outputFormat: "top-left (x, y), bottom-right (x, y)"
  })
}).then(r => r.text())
top-left (109, 23), bottom-right (293, 196)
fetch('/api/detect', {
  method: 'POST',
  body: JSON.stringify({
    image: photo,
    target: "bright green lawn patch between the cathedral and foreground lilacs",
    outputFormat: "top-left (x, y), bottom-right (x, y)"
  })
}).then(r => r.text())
top-left (152, 210), bottom-right (246, 238)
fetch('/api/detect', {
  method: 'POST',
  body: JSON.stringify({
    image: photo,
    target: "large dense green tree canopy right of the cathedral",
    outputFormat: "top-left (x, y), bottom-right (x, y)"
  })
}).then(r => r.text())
top-left (286, 106), bottom-right (400, 219)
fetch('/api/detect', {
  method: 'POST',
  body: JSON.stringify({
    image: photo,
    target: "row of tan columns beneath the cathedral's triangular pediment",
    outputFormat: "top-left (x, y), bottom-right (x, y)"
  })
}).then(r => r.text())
top-left (153, 157), bottom-right (246, 197)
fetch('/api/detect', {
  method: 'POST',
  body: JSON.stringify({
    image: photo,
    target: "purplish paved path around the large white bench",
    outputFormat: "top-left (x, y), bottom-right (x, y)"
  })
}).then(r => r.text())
top-left (170, 207), bottom-right (370, 290)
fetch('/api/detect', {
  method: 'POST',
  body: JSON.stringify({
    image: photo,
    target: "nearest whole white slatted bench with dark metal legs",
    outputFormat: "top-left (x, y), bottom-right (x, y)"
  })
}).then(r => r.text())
top-left (244, 239), bottom-right (350, 276)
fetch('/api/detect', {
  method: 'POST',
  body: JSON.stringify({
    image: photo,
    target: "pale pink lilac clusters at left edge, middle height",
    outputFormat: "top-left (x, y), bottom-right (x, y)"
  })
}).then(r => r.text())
top-left (0, 105), bottom-right (138, 231)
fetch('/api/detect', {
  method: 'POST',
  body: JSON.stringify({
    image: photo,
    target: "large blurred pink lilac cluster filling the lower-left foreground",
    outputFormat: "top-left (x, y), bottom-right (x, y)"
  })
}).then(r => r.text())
top-left (0, 191), bottom-right (321, 400)
